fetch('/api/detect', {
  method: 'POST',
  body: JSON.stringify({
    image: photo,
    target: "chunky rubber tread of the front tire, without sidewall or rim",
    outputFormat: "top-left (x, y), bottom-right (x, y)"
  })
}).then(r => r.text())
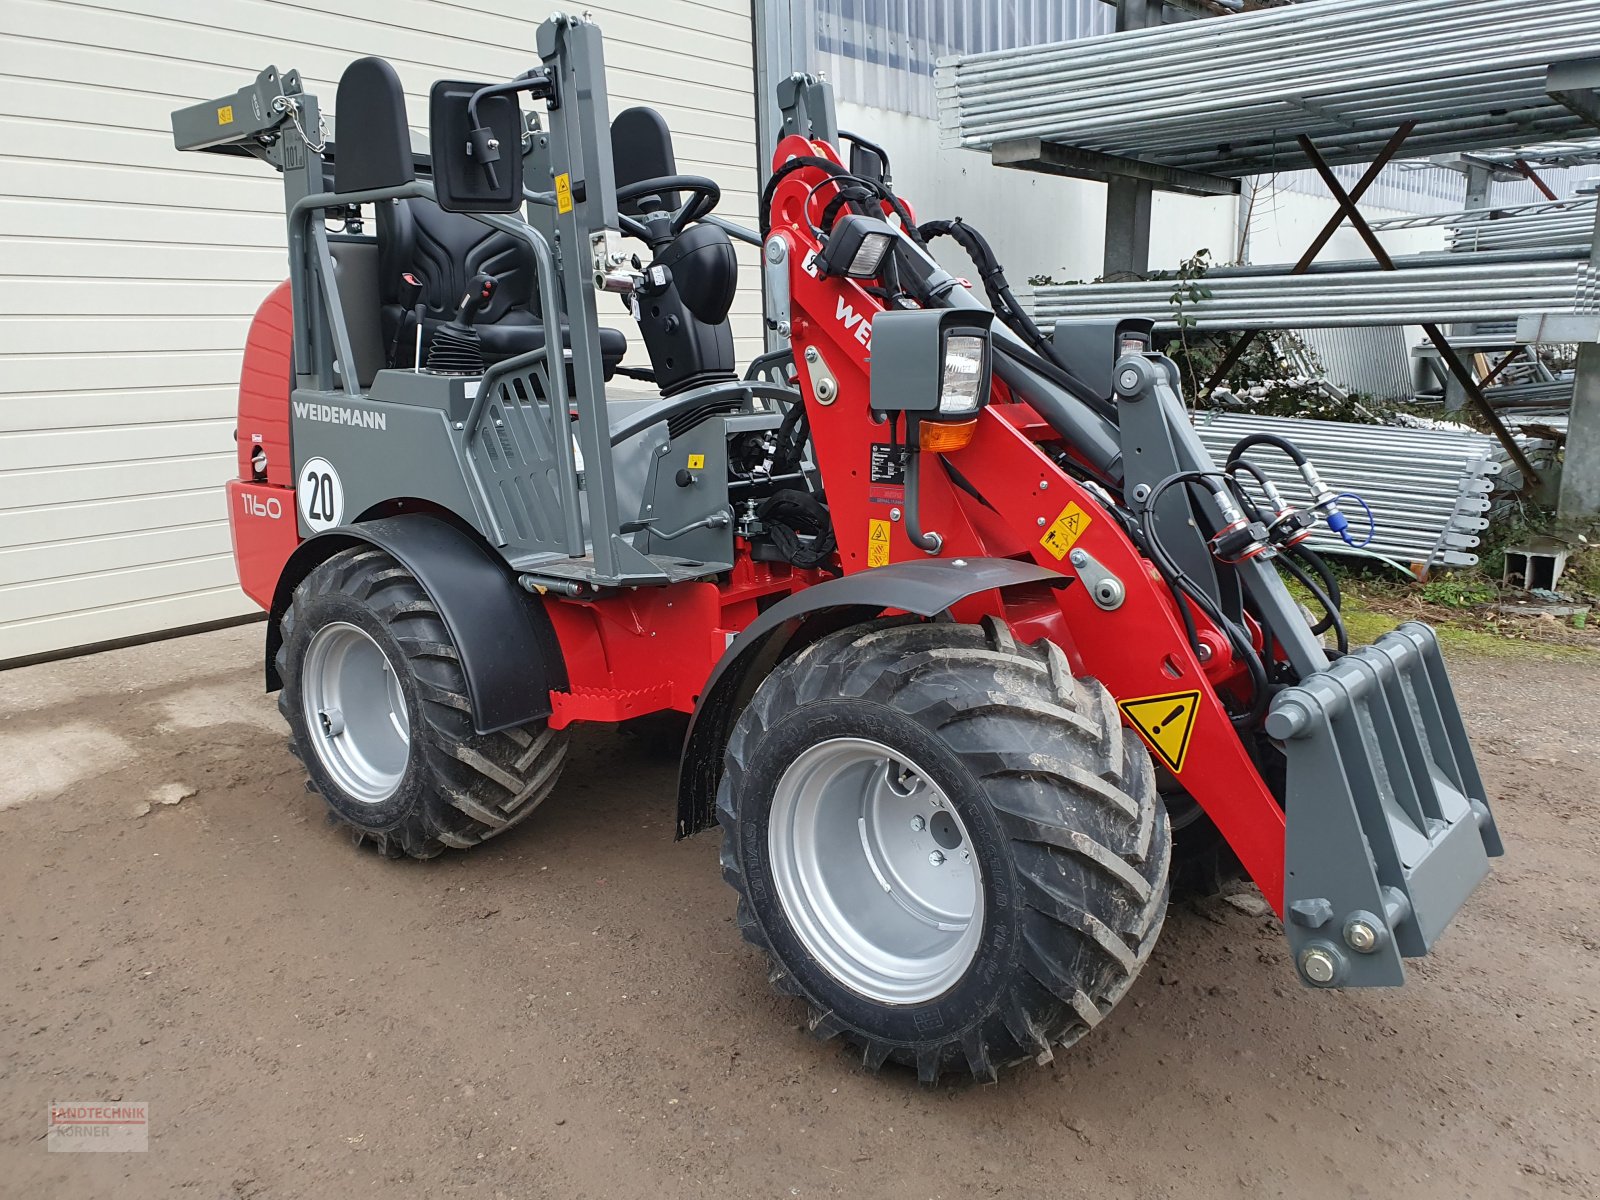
top-left (717, 618), bottom-right (1170, 1085)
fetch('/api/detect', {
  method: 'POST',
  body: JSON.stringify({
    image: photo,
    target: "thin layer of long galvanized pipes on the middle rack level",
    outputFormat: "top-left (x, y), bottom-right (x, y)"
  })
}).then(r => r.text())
top-left (1032, 259), bottom-right (1600, 330)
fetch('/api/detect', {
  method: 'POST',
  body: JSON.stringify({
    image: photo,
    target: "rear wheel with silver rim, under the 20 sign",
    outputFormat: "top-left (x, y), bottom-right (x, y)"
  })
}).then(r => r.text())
top-left (277, 547), bottom-right (566, 858)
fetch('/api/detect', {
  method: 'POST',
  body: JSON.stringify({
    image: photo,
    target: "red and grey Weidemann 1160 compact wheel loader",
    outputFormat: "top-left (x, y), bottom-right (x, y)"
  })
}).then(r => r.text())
top-left (173, 16), bottom-right (1501, 1082)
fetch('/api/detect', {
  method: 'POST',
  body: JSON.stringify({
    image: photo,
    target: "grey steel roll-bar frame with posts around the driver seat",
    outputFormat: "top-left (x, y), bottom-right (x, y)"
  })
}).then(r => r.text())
top-left (173, 16), bottom-right (694, 586)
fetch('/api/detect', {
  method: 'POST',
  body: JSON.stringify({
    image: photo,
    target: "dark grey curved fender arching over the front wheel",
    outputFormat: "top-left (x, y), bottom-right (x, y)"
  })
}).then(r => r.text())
top-left (678, 558), bottom-right (1072, 837)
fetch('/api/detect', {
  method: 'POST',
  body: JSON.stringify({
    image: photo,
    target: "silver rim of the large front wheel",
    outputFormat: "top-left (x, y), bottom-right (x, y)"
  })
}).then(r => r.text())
top-left (766, 738), bottom-right (984, 1005)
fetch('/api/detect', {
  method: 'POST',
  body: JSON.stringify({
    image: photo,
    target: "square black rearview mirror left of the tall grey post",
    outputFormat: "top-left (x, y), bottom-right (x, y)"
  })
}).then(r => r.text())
top-left (427, 80), bottom-right (522, 213)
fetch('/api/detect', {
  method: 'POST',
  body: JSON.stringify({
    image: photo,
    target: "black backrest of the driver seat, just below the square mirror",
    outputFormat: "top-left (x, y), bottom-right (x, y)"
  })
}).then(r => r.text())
top-left (378, 200), bottom-right (538, 325)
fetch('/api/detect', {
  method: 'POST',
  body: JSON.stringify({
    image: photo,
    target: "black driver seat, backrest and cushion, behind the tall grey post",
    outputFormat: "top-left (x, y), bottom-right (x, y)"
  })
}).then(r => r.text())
top-left (378, 200), bottom-right (627, 379)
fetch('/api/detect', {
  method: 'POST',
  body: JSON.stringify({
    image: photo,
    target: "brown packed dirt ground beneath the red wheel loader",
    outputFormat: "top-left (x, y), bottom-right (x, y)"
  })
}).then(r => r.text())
top-left (0, 626), bottom-right (1600, 1200)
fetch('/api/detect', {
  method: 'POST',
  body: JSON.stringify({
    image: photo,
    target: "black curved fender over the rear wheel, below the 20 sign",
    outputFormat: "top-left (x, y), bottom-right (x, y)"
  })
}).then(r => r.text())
top-left (267, 514), bottom-right (566, 733)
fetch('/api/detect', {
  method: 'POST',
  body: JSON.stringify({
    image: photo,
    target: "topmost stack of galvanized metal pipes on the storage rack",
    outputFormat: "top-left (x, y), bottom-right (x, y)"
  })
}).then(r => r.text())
top-left (936, 0), bottom-right (1600, 176)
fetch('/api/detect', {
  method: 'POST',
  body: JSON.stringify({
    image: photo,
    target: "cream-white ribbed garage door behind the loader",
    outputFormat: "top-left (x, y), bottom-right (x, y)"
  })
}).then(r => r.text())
top-left (0, 0), bottom-right (760, 662)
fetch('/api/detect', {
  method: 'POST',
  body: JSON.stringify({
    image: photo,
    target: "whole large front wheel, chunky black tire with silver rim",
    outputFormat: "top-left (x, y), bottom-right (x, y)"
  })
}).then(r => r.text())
top-left (717, 621), bottom-right (1170, 1083)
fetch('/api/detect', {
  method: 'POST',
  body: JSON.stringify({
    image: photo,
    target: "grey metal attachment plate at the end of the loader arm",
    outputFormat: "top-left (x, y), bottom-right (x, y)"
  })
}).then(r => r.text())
top-left (1267, 621), bottom-right (1504, 987)
